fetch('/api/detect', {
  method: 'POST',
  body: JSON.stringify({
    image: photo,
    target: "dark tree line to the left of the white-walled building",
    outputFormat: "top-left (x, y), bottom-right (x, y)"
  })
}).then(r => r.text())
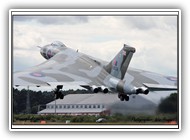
top-left (12, 88), bottom-right (88, 114)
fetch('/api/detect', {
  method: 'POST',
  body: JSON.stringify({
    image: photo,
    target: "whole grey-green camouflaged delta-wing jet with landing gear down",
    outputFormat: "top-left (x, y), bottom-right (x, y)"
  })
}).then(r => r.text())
top-left (13, 41), bottom-right (177, 101)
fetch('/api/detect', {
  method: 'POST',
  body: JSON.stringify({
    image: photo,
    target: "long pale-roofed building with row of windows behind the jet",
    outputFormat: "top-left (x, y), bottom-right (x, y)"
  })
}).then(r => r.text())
top-left (38, 94), bottom-right (113, 115)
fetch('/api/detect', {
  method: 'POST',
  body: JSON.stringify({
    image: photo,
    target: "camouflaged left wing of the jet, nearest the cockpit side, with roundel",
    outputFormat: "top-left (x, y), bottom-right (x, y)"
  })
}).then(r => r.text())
top-left (13, 48), bottom-right (107, 86)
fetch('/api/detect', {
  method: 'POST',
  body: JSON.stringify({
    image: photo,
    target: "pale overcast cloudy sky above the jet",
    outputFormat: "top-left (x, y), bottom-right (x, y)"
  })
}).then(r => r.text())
top-left (13, 13), bottom-right (177, 76)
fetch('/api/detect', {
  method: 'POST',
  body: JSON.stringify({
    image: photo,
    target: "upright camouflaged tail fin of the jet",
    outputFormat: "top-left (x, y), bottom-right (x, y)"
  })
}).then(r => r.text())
top-left (104, 44), bottom-right (135, 79)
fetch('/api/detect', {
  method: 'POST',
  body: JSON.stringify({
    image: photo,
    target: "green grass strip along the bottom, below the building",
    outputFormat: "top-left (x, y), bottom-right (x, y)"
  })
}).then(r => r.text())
top-left (13, 114), bottom-right (177, 125)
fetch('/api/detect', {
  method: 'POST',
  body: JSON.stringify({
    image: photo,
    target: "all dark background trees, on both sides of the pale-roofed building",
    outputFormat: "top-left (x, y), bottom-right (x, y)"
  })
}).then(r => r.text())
top-left (12, 88), bottom-right (178, 114)
